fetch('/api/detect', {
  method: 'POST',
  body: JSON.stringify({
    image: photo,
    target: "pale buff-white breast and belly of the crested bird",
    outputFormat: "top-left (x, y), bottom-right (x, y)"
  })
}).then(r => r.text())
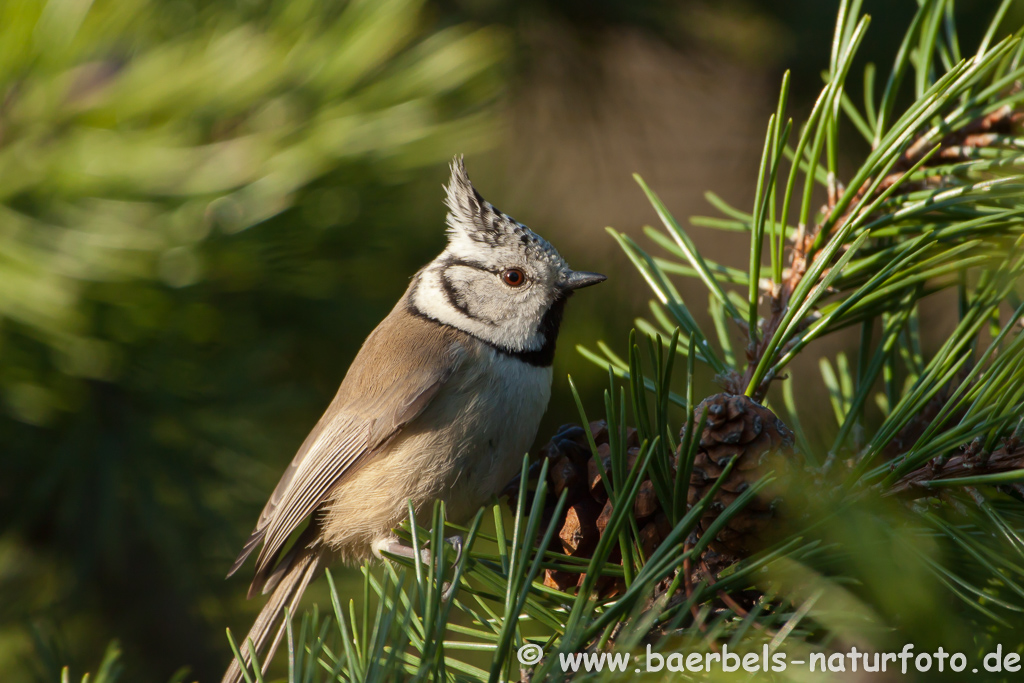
top-left (322, 338), bottom-right (551, 561)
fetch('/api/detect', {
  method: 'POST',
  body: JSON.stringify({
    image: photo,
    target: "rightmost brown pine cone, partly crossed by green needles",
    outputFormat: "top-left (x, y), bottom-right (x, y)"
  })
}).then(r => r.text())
top-left (680, 393), bottom-right (794, 577)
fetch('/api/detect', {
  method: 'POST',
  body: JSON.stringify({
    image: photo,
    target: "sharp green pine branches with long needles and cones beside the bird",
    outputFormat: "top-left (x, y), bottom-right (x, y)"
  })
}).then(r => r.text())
top-left (205, 0), bottom-right (1024, 681)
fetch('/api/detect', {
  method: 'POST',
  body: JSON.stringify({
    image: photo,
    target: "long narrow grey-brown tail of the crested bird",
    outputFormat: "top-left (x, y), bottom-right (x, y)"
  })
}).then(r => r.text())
top-left (221, 544), bottom-right (323, 683)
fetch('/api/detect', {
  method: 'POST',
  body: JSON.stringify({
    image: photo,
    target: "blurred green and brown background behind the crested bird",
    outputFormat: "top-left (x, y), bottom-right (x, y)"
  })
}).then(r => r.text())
top-left (0, 0), bottom-right (1015, 683)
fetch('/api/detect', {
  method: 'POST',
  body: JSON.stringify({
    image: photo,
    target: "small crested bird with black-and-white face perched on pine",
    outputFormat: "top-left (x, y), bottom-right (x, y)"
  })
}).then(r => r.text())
top-left (222, 156), bottom-right (606, 683)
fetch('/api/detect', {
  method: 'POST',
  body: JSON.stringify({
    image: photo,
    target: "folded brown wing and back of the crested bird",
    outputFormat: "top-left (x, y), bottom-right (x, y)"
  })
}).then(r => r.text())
top-left (227, 299), bottom-right (463, 592)
